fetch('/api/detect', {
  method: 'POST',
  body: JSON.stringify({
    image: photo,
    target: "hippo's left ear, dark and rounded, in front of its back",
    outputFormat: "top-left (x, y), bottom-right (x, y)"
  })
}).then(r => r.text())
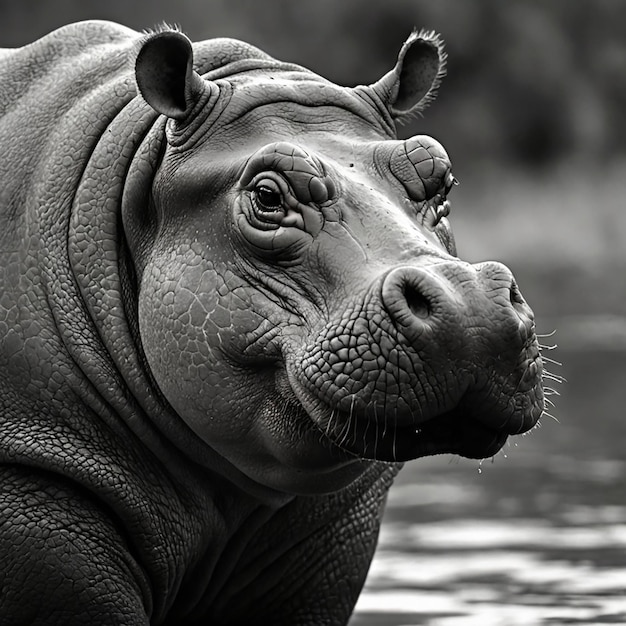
top-left (135, 31), bottom-right (205, 120)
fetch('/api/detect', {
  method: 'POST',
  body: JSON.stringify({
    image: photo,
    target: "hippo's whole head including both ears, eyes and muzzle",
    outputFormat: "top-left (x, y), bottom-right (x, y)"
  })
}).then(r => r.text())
top-left (130, 32), bottom-right (543, 493)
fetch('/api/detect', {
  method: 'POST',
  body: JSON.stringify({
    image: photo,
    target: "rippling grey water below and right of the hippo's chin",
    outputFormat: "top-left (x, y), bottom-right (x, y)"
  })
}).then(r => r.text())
top-left (351, 344), bottom-right (626, 626)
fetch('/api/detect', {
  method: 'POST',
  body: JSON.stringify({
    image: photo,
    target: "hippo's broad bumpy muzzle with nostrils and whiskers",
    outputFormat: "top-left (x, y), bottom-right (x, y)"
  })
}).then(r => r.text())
top-left (288, 261), bottom-right (543, 461)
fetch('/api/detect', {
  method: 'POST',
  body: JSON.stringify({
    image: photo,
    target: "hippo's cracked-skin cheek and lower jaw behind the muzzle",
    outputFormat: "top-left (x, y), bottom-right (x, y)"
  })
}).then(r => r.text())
top-left (139, 254), bottom-right (363, 493)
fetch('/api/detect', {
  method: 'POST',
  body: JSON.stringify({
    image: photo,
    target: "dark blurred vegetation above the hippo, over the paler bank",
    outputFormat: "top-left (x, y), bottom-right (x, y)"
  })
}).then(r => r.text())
top-left (0, 0), bottom-right (626, 169)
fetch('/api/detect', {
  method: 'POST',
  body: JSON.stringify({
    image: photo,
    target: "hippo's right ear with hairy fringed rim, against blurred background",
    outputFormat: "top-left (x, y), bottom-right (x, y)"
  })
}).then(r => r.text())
top-left (370, 31), bottom-right (447, 122)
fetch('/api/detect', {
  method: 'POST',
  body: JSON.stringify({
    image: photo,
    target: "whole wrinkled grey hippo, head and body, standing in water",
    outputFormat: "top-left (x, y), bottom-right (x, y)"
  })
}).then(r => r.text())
top-left (0, 22), bottom-right (543, 626)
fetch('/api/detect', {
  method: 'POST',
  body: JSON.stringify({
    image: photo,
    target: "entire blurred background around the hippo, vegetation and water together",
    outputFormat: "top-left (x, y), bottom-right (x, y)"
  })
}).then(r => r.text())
top-left (0, 0), bottom-right (626, 626)
